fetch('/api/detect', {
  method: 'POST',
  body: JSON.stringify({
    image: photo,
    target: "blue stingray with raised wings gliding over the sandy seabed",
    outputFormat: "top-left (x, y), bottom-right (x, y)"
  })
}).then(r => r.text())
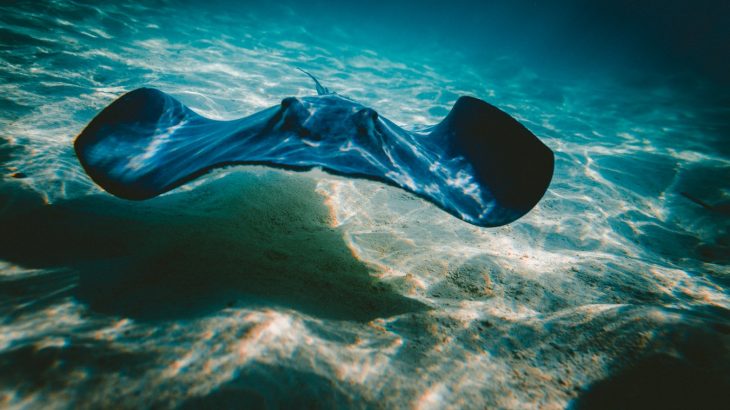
top-left (74, 72), bottom-right (554, 227)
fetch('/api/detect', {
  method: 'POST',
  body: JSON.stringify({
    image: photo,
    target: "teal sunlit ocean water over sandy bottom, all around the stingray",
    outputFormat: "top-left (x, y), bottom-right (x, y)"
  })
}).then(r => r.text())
top-left (0, 0), bottom-right (730, 409)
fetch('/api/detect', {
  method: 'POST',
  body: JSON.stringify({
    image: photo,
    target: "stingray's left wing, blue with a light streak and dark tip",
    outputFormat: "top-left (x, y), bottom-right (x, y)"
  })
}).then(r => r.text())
top-left (74, 88), bottom-right (281, 199)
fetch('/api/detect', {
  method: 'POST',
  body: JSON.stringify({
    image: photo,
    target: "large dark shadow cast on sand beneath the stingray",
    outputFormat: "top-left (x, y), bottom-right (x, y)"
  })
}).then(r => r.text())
top-left (0, 168), bottom-right (426, 321)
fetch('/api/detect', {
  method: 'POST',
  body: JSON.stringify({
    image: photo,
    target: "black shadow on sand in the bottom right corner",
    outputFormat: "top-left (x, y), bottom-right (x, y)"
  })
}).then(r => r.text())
top-left (569, 306), bottom-right (730, 410)
